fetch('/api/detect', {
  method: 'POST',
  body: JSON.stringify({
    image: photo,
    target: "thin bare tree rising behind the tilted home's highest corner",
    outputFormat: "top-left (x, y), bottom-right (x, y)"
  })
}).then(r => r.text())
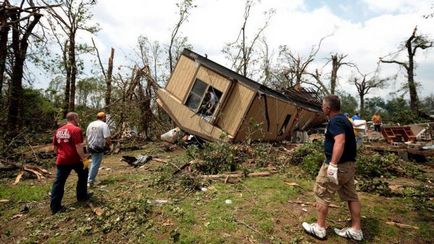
top-left (168, 0), bottom-right (196, 73)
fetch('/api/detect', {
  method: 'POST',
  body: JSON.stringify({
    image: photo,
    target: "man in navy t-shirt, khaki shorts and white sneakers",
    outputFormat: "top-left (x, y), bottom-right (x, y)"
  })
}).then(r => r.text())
top-left (302, 95), bottom-right (363, 241)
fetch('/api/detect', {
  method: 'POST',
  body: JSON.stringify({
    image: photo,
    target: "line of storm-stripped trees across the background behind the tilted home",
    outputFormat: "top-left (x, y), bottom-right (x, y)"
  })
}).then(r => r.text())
top-left (0, 0), bottom-right (434, 147)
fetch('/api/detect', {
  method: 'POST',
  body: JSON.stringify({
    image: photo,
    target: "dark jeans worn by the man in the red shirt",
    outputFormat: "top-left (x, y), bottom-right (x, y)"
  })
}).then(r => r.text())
top-left (50, 162), bottom-right (89, 213)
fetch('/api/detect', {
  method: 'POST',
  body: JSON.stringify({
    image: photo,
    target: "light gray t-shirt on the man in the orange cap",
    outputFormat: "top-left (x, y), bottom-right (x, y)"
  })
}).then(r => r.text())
top-left (86, 120), bottom-right (110, 148)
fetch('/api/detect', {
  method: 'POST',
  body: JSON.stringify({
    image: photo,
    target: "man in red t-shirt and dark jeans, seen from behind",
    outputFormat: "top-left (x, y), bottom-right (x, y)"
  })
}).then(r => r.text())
top-left (50, 112), bottom-right (89, 214)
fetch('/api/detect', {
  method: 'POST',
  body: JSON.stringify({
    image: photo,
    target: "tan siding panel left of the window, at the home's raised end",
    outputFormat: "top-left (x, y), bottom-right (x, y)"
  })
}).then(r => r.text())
top-left (166, 56), bottom-right (198, 103)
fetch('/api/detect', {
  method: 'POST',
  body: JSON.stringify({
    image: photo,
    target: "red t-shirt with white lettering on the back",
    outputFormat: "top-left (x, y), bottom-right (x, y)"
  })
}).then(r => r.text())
top-left (53, 124), bottom-right (83, 165)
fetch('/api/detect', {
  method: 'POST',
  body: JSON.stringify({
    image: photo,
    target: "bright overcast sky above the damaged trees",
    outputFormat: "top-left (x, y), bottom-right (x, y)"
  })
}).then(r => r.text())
top-left (38, 0), bottom-right (434, 100)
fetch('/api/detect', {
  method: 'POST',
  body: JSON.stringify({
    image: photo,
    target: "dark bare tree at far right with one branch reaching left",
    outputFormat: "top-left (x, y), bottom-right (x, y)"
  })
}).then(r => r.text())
top-left (380, 26), bottom-right (433, 113)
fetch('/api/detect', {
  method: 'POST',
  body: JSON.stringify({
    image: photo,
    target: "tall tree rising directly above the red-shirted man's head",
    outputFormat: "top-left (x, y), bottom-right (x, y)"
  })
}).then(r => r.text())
top-left (43, 0), bottom-right (98, 114)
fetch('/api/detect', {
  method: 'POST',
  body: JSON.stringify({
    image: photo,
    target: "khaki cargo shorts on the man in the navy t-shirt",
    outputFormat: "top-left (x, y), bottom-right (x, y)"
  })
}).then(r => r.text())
top-left (313, 162), bottom-right (359, 206)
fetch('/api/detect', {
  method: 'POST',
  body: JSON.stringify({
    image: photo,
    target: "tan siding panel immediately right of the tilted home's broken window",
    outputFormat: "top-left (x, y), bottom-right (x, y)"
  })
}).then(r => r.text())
top-left (217, 83), bottom-right (255, 135)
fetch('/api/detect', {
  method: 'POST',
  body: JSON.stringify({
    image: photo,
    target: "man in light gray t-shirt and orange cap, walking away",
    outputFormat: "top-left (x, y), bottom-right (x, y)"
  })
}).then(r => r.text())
top-left (86, 112), bottom-right (111, 187)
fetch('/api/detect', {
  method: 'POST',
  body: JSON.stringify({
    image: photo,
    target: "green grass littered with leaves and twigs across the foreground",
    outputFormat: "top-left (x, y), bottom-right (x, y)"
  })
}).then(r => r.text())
top-left (0, 146), bottom-right (434, 243)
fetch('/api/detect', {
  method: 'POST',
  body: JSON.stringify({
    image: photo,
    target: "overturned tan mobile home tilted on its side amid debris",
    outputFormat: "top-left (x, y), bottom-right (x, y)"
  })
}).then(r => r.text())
top-left (158, 49), bottom-right (325, 142)
